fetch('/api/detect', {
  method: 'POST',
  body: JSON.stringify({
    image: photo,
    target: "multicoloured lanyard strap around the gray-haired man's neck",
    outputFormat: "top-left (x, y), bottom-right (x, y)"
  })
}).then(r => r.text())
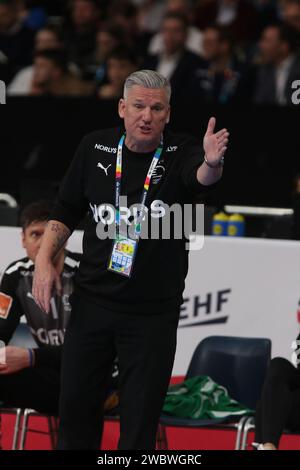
top-left (115, 134), bottom-right (163, 235)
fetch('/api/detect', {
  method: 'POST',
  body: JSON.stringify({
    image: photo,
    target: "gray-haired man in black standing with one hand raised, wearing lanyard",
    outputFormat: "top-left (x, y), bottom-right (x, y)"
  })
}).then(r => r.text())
top-left (33, 70), bottom-right (229, 450)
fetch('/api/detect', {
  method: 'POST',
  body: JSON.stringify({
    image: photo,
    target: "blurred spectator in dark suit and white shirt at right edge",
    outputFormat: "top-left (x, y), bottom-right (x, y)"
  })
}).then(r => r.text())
top-left (254, 25), bottom-right (300, 105)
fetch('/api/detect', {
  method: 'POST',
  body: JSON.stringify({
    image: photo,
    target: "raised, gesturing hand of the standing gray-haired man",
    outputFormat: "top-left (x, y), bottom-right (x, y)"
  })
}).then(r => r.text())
top-left (203, 117), bottom-right (229, 166)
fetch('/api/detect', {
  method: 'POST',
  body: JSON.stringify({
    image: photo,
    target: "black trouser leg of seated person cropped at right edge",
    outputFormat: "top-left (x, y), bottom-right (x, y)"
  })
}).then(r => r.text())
top-left (255, 357), bottom-right (300, 447)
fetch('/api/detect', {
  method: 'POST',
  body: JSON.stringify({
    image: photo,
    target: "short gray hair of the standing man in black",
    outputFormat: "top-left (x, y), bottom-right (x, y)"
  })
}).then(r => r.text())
top-left (123, 70), bottom-right (171, 101)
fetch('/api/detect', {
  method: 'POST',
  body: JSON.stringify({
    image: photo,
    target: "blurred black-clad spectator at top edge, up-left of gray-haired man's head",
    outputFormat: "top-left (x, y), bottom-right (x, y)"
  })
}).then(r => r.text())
top-left (64, 0), bottom-right (101, 78)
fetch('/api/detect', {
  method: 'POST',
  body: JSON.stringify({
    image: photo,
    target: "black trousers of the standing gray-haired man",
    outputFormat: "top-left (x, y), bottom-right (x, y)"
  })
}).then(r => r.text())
top-left (58, 296), bottom-right (179, 450)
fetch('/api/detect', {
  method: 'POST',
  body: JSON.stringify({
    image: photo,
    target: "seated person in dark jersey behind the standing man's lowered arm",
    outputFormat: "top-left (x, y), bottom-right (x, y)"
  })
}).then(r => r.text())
top-left (0, 201), bottom-right (117, 414)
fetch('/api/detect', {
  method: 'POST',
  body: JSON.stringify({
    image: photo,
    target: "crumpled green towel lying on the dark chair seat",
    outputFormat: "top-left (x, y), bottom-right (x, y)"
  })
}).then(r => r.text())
top-left (163, 375), bottom-right (253, 419)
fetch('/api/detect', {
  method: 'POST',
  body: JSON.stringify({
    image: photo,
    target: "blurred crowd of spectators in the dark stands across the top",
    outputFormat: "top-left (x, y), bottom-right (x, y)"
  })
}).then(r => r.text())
top-left (0, 0), bottom-right (300, 105)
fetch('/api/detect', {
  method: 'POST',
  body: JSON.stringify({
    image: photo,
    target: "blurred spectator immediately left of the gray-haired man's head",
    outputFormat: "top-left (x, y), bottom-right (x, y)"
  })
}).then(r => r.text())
top-left (97, 46), bottom-right (138, 99)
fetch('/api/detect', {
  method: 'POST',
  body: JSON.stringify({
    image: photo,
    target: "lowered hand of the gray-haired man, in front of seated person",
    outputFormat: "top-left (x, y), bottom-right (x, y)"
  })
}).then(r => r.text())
top-left (32, 256), bottom-right (62, 313)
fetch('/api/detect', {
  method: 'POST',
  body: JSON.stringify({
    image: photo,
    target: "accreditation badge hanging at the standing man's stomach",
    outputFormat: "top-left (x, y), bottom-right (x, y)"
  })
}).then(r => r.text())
top-left (108, 234), bottom-right (138, 277)
